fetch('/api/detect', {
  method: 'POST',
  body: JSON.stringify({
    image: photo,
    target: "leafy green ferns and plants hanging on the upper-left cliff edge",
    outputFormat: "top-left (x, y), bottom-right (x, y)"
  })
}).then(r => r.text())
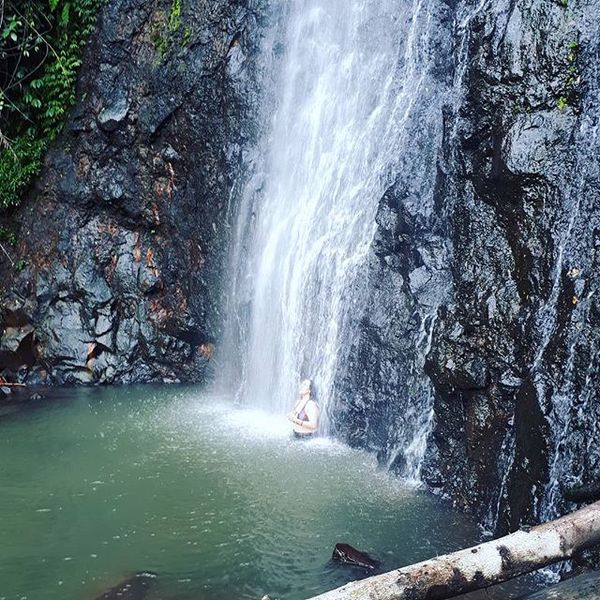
top-left (0, 0), bottom-right (102, 210)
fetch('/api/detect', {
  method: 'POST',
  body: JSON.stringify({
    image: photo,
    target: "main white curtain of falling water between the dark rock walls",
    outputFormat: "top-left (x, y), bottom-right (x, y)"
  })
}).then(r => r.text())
top-left (223, 0), bottom-right (446, 450)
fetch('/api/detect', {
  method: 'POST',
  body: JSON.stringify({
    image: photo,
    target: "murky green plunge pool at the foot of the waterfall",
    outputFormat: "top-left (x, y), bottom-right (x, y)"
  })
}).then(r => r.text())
top-left (0, 386), bottom-right (477, 600)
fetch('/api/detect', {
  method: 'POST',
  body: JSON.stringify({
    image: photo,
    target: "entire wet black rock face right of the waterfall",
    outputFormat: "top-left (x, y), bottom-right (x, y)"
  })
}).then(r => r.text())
top-left (338, 0), bottom-right (600, 532)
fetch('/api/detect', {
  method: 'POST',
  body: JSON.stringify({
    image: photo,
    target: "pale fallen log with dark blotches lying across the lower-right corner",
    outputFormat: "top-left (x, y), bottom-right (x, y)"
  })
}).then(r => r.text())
top-left (310, 502), bottom-right (600, 600)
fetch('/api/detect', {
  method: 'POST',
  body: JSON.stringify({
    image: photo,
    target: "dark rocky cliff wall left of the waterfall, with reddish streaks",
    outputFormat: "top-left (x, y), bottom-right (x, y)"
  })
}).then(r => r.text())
top-left (0, 0), bottom-right (264, 383)
